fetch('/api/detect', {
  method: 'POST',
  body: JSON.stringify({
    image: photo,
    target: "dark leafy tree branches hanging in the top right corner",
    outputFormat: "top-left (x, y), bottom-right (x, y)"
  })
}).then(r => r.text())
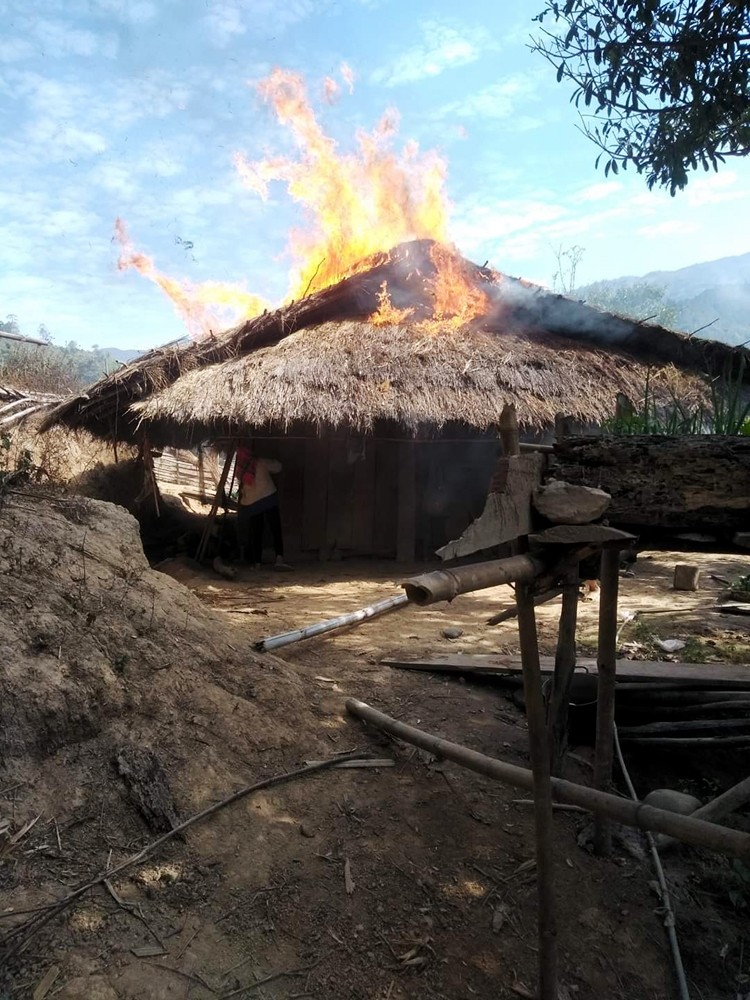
top-left (532, 0), bottom-right (750, 194)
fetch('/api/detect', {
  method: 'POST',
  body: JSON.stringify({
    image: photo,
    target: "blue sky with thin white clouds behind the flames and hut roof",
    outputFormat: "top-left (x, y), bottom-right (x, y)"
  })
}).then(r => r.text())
top-left (0, 0), bottom-right (750, 349)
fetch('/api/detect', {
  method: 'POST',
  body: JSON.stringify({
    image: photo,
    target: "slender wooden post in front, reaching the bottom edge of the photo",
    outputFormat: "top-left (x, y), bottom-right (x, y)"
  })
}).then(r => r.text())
top-left (516, 583), bottom-right (557, 1000)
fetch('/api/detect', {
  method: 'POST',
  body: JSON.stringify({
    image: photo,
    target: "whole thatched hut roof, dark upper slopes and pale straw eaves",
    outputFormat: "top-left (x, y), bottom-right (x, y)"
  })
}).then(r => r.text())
top-left (45, 241), bottom-right (750, 443)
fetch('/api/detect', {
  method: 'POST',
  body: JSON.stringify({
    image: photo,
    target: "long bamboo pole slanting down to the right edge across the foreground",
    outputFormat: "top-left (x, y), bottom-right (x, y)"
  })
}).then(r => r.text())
top-left (346, 698), bottom-right (750, 860)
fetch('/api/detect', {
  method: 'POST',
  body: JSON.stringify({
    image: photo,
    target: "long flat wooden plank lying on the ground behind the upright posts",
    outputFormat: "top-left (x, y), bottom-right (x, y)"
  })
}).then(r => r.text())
top-left (382, 653), bottom-right (750, 690)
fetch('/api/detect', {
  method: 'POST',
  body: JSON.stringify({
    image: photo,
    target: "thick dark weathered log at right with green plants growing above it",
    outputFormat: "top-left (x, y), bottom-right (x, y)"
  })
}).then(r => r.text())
top-left (553, 435), bottom-right (750, 537)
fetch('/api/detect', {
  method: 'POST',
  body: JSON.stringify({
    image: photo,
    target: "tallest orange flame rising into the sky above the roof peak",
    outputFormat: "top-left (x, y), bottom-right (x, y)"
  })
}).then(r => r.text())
top-left (235, 69), bottom-right (448, 298)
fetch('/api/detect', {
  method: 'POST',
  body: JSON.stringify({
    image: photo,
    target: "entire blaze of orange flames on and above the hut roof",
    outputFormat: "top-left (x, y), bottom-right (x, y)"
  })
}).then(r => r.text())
top-left (117, 63), bottom-right (489, 336)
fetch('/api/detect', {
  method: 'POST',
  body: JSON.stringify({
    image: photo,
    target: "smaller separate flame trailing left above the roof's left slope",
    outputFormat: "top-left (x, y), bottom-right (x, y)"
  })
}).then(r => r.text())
top-left (115, 219), bottom-right (267, 339)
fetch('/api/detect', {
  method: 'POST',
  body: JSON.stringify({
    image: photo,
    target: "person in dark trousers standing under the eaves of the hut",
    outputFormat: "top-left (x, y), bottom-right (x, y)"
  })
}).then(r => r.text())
top-left (235, 444), bottom-right (290, 570)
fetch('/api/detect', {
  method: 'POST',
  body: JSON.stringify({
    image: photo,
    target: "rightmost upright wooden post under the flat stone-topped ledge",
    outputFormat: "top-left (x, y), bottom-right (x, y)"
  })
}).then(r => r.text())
top-left (594, 548), bottom-right (620, 855)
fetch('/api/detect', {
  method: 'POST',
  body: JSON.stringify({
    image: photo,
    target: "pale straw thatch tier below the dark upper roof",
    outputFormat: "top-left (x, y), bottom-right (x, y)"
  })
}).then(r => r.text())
top-left (134, 320), bottom-right (704, 441)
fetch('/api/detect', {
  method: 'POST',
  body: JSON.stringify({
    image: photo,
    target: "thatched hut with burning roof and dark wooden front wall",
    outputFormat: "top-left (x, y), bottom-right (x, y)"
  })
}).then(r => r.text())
top-left (39, 241), bottom-right (750, 559)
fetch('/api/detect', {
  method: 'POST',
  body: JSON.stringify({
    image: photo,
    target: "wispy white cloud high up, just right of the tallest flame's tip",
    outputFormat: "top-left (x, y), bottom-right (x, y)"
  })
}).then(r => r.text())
top-left (370, 21), bottom-right (494, 87)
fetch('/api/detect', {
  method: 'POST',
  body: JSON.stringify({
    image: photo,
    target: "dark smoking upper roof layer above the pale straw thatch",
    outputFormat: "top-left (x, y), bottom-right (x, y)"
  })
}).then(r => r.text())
top-left (42, 240), bottom-right (750, 440)
